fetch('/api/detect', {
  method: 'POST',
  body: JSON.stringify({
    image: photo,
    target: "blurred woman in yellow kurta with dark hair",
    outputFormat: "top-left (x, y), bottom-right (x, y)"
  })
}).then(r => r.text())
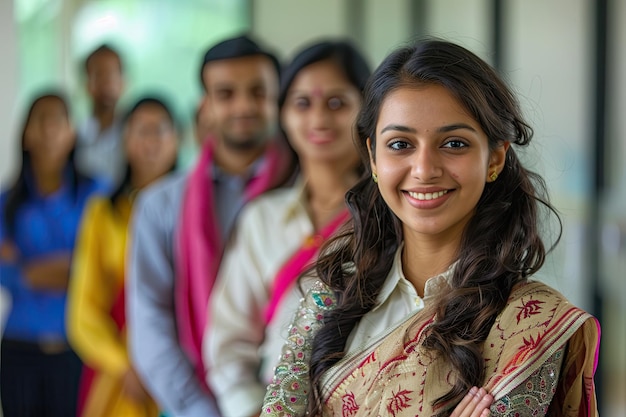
top-left (67, 98), bottom-right (178, 417)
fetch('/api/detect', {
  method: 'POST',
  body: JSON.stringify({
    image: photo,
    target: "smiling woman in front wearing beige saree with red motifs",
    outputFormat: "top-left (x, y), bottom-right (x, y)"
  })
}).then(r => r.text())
top-left (262, 40), bottom-right (600, 417)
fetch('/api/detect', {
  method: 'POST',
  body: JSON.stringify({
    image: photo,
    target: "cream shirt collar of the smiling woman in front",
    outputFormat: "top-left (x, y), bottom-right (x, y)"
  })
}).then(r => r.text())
top-left (374, 243), bottom-right (458, 310)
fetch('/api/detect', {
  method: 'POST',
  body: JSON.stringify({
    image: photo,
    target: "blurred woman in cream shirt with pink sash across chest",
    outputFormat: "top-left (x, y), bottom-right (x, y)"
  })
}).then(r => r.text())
top-left (204, 40), bottom-right (370, 417)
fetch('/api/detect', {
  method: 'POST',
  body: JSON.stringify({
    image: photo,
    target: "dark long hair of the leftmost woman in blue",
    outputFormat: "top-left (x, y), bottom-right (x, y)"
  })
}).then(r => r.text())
top-left (2, 91), bottom-right (87, 239)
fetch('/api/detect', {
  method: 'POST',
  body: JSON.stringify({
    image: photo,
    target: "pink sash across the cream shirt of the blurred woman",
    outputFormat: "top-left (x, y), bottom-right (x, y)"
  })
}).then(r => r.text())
top-left (265, 209), bottom-right (350, 324)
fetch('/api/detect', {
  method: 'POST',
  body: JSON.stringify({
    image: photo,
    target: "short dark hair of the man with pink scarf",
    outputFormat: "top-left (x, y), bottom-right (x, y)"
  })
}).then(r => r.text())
top-left (200, 35), bottom-right (280, 88)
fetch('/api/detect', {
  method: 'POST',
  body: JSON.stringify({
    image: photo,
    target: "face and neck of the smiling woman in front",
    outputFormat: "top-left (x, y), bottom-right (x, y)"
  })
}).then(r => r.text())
top-left (368, 84), bottom-right (509, 266)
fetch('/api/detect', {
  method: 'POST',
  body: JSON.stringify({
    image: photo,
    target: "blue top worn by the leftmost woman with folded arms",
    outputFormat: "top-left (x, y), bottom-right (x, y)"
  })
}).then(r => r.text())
top-left (0, 169), bottom-right (108, 342)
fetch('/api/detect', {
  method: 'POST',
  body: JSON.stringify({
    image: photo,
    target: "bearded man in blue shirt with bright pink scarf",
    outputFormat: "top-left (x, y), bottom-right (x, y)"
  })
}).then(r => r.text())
top-left (127, 36), bottom-right (293, 417)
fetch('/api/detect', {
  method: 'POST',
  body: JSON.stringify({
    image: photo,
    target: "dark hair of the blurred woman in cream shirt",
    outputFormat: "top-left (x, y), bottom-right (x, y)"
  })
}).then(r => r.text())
top-left (278, 40), bottom-right (371, 107)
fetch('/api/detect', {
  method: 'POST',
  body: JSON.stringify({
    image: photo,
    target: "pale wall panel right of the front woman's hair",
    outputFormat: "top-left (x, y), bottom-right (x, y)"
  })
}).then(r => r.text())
top-left (505, 0), bottom-right (594, 308)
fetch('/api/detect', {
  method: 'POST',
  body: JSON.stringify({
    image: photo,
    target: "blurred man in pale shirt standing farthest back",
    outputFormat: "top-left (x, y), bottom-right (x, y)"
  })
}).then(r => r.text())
top-left (76, 44), bottom-right (126, 187)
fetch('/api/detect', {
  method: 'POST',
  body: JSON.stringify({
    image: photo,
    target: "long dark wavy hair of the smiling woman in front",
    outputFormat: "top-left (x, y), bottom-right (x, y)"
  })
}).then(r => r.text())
top-left (309, 39), bottom-right (561, 415)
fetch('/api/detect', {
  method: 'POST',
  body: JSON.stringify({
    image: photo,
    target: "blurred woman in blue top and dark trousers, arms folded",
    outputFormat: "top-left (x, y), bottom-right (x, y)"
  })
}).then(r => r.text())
top-left (0, 94), bottom-right (104, 417)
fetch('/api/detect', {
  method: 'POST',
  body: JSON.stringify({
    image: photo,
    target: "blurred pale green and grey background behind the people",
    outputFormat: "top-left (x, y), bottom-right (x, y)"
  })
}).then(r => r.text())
top-left (0, 0), bottom-right (626, 417)
